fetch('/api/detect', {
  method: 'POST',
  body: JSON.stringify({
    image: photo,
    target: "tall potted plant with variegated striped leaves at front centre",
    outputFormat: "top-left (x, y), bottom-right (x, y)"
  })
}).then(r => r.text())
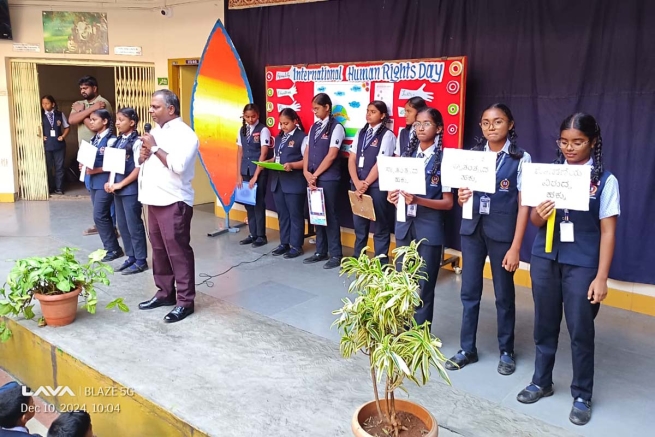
top-left (333, 242), bottom-right (450, 437)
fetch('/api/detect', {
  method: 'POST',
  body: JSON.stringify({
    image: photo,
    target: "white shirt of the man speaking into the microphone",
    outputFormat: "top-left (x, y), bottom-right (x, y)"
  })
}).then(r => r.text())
top-left (139, 117), bottom-right (199, 206)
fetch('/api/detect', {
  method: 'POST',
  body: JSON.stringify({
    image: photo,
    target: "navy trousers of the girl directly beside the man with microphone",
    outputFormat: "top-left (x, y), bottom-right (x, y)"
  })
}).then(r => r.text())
top-left (114, 194), bottom-right (148, 261)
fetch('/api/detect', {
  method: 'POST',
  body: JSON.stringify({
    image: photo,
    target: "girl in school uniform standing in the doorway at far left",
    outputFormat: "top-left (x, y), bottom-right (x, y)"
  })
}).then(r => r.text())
top-left (41, 95), bottom-right (70, 194)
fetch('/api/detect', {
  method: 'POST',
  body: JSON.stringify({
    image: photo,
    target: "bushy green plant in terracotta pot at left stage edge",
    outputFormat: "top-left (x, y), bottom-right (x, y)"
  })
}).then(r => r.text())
top-left (0, 247), bottom-right (129, 342)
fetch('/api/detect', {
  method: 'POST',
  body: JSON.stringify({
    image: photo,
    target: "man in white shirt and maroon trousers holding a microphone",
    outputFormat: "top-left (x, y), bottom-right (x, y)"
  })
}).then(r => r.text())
top-left (139, 90), bottom-right (198, 323)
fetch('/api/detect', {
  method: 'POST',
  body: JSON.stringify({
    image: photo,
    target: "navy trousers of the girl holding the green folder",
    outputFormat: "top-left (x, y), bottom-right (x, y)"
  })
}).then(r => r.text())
top-left (273, 186), bottom-right (307, 250)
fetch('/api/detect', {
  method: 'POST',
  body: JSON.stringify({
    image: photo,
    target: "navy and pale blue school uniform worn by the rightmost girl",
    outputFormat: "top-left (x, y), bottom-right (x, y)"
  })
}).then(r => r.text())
top-left (530, 160), bottom-right (621, 401)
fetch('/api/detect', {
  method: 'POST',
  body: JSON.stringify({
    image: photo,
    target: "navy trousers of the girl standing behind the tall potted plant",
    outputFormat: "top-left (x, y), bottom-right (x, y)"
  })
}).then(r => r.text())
top-left (396, 225), bottom-right (441, 325)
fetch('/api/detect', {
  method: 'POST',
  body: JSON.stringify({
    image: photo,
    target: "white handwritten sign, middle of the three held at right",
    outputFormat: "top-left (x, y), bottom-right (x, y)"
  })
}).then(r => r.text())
top-left (441, 148), bottom-right (496, 194)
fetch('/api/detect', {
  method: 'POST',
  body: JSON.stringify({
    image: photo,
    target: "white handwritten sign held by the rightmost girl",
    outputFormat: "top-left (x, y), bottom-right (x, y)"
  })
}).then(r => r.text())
top-left (521, 163), bottom-right (591, 211)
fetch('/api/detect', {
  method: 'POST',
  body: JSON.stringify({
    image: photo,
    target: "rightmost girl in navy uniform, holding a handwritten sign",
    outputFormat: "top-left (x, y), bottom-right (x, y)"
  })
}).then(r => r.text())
top-left (517, 113), bottom-right (621, 425)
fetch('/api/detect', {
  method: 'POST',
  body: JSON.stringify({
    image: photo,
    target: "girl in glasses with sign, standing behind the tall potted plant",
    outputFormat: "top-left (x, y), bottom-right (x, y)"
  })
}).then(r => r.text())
top-left (387, 108), bottom-right (453, 325)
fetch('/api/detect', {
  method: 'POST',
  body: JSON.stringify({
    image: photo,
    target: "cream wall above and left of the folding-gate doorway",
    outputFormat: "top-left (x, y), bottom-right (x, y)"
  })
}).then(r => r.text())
top-left (0, 0), bottom-right (224, 201)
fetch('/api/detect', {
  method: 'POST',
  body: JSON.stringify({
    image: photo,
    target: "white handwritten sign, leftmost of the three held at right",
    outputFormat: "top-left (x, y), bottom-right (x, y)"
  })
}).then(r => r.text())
top-left (378, 156), bottom-right (425, 194)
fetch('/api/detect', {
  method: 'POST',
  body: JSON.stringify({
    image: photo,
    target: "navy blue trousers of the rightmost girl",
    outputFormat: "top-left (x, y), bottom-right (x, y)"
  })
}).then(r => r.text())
top-left (530, 256), bottom-right (600, 401)
